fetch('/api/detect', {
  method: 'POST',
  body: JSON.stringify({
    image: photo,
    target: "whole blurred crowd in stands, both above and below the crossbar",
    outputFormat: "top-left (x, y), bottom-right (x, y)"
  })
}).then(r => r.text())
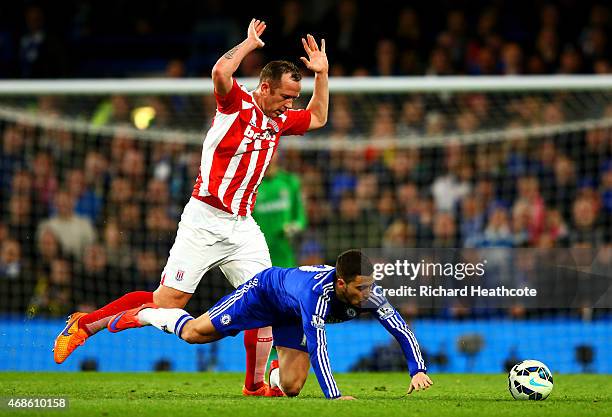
top-left (0, 0), bottom-right (612, 316)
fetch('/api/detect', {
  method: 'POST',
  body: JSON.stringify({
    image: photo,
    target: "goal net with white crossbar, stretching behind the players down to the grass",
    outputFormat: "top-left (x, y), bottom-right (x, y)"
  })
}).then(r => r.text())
top-left (0, 76), bottom-right (612, 373)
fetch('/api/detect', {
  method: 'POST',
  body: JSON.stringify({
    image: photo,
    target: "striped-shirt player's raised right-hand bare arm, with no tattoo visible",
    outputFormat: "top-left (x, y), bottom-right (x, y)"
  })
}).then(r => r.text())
top-left (300, 35), bottom-right (329, 130)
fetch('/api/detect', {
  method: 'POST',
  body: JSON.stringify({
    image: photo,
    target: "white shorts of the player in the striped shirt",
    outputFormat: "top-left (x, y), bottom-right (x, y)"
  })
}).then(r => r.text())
top-left (161, 197), bottom-right (272, 294)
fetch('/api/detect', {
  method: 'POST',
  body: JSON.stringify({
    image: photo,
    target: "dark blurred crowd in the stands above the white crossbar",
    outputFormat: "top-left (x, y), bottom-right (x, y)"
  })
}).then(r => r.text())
top-left (0, 0), bottom-right (612, 78)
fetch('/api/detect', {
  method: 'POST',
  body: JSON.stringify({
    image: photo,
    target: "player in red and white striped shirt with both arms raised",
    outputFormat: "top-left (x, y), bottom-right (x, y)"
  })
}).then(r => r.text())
top-left (54, 19), bottom-right (329, 395)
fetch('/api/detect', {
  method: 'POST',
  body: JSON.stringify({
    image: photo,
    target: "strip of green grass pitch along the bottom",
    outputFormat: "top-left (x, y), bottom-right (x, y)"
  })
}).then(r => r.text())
top-left (0, 373), bottom-right (612, 417)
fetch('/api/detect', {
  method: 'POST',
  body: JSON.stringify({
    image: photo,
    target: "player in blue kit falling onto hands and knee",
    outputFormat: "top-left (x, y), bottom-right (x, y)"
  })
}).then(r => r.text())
top-left (108, 250), bottom-right (432, 399)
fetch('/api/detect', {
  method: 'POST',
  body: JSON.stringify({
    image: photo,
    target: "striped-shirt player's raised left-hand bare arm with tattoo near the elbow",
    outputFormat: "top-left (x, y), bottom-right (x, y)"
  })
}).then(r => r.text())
top-left (212, 19), bottom-right (266, 96)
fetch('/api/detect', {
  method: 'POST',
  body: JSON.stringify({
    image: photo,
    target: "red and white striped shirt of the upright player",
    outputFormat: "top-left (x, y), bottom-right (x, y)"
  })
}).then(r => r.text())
top-left (191, 79), bottom-right (310, 216)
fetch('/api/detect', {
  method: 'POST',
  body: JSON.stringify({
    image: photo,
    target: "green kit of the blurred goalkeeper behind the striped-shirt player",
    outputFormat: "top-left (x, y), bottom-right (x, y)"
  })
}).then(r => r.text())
top-left (253, 170), bottom-right (306, 268)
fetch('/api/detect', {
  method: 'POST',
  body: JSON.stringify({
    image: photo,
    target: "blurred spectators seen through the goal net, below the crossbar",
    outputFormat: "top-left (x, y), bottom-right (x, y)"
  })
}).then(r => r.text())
top-left (0, 95), bottom-right (612, 314)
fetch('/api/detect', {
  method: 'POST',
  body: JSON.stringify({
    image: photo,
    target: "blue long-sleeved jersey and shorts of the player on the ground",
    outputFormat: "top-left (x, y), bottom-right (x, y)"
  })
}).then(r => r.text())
top-left (209, 265), bottom-right (426, 398)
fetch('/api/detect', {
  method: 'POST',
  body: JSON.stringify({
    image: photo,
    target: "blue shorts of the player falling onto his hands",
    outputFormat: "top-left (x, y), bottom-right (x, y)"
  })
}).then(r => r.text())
top-left (208, 276), bottom-right (308, 352)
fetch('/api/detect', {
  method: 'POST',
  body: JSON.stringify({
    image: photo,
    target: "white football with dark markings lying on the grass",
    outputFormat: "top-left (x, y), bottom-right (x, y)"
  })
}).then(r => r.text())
top-left (508, 360), bottom-right (553, 401)
